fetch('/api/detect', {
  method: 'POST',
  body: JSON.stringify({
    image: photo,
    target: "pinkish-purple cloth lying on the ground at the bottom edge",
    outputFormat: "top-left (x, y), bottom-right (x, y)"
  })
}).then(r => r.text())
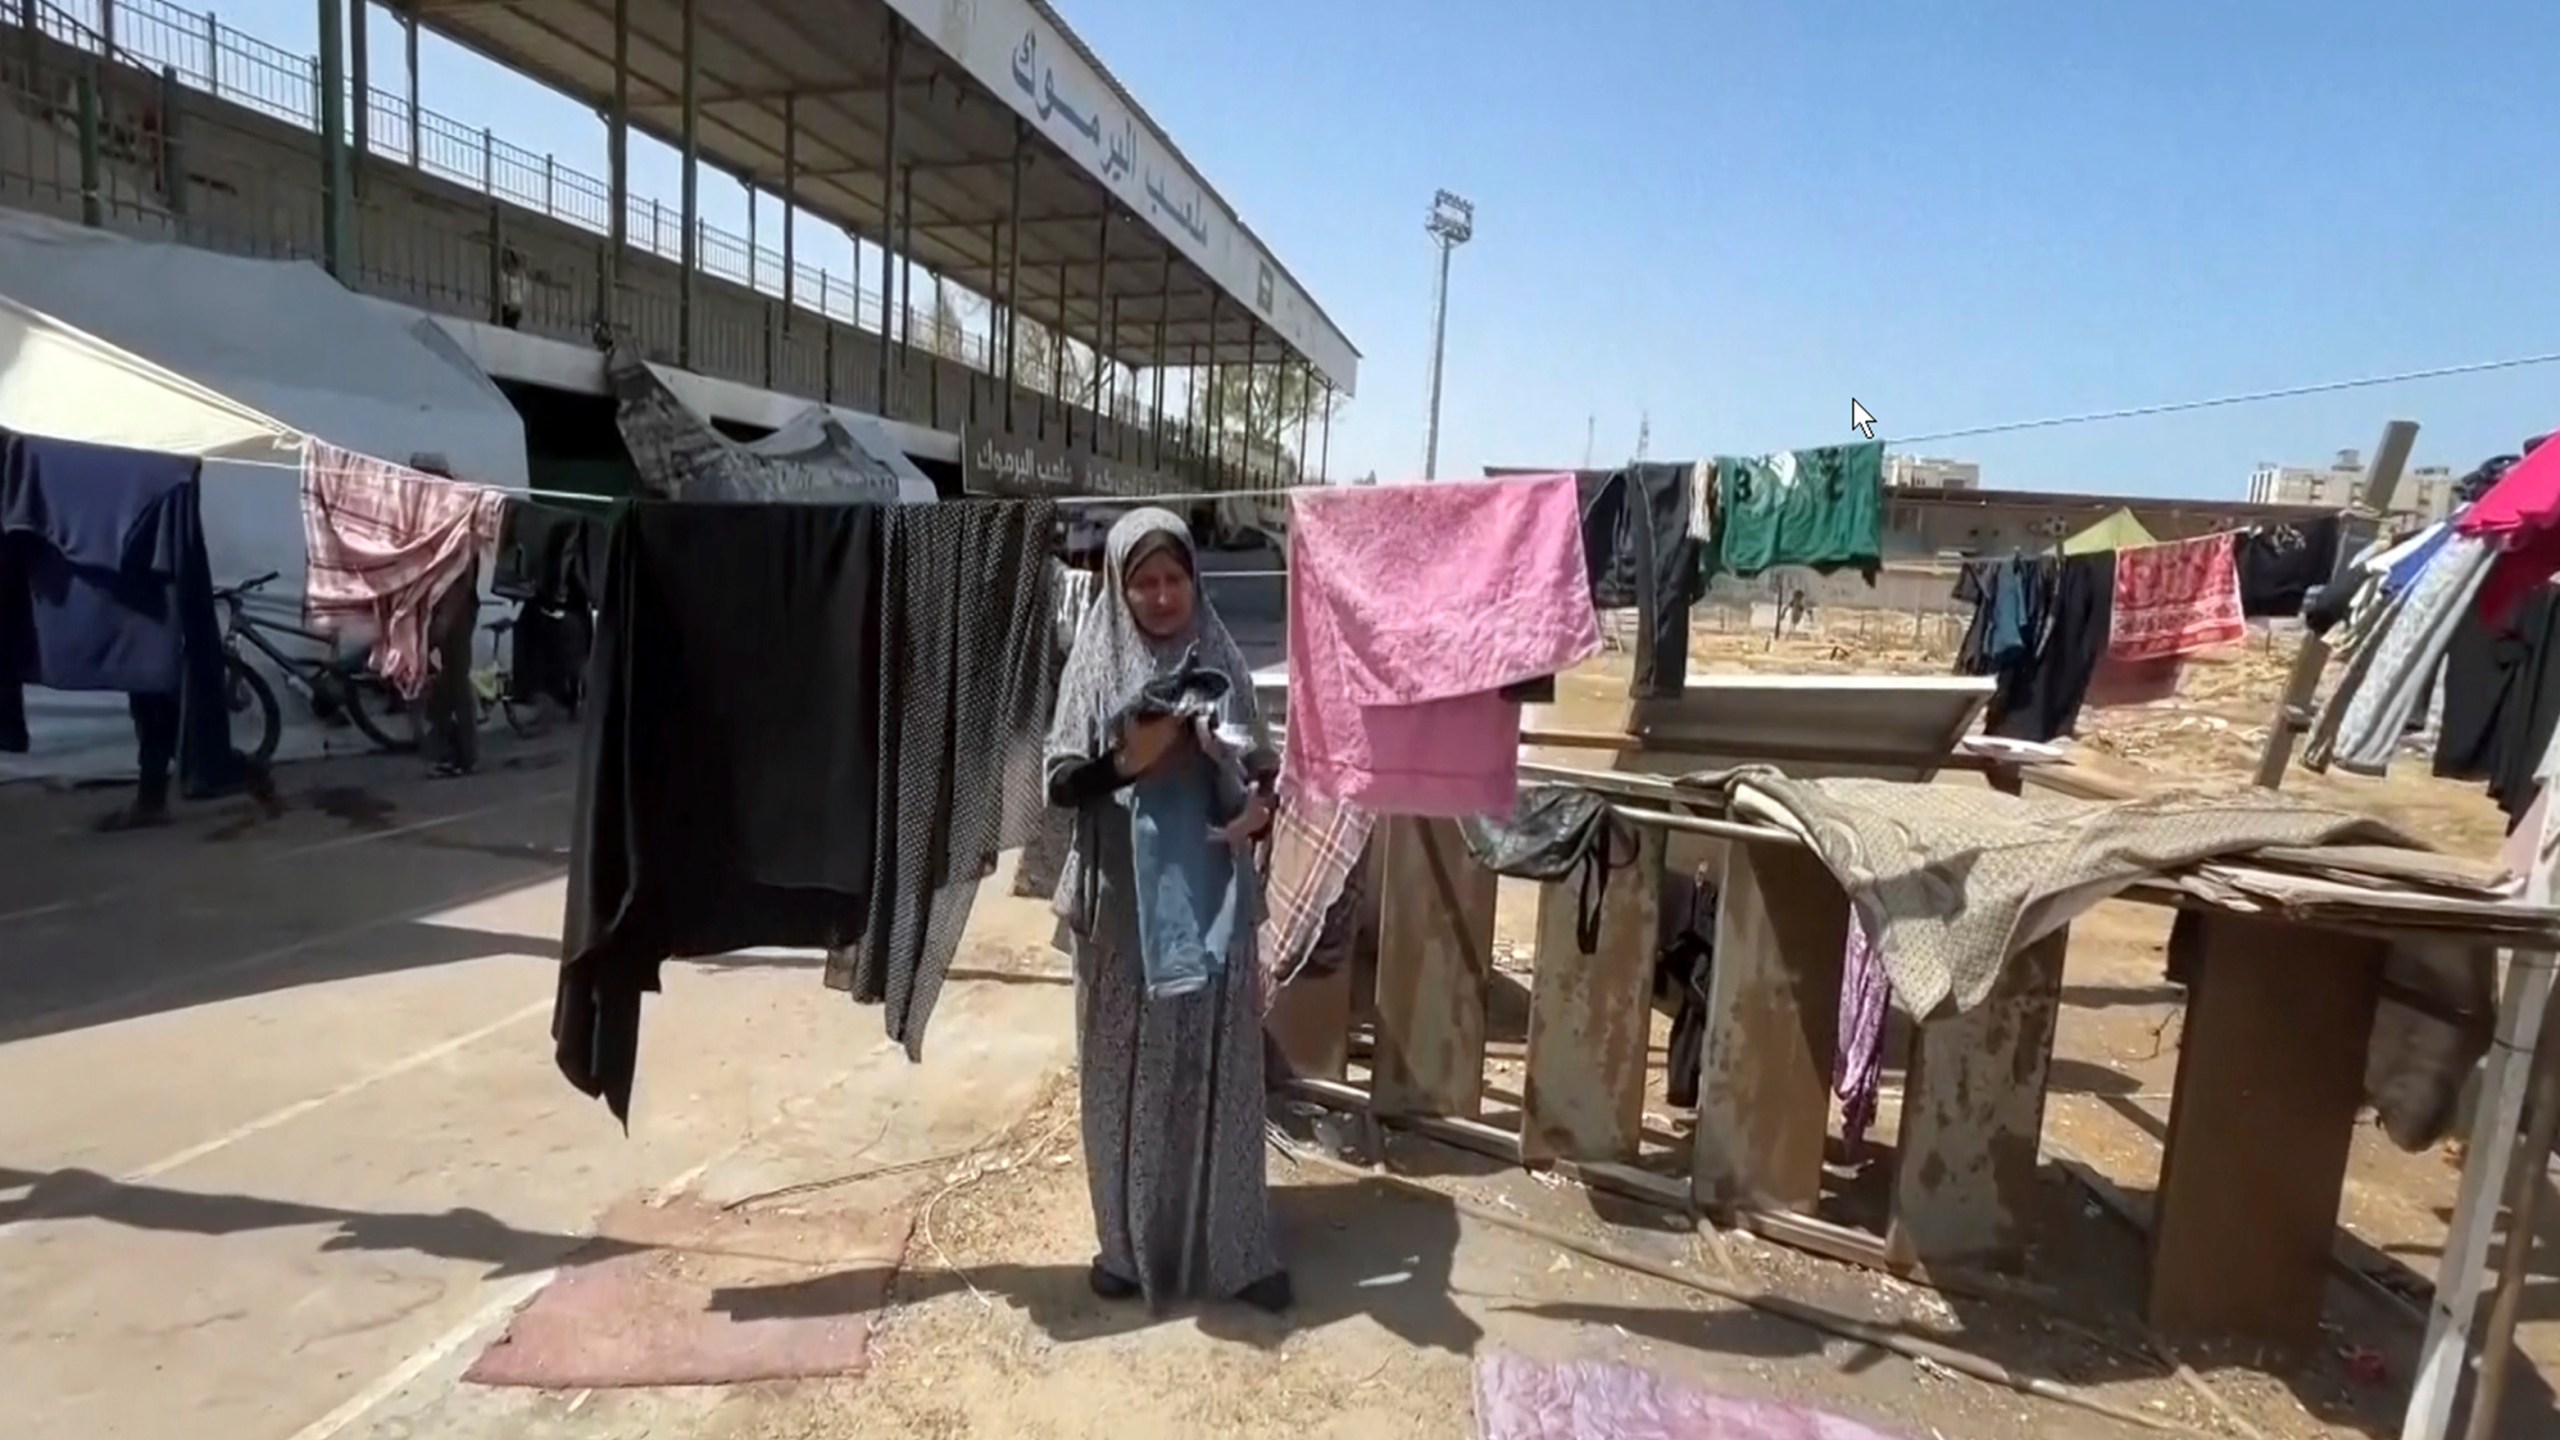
top-left (1475, 1353), bottom-right (1894, 1440)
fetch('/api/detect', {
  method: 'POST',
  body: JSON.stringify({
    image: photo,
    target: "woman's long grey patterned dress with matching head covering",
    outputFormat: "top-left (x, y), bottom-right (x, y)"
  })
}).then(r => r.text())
top-left (1047, 510), bottom-right (1280, 1307)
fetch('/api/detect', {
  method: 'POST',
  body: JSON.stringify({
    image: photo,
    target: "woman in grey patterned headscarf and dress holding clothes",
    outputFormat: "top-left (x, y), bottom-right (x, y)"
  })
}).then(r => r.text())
top-left (1047, 510), bottom-right (1290, 1312)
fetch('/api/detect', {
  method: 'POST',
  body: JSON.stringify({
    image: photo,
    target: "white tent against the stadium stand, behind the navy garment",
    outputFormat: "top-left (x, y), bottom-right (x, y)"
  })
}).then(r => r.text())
top-left (0, 210), bottom-right (527, 779)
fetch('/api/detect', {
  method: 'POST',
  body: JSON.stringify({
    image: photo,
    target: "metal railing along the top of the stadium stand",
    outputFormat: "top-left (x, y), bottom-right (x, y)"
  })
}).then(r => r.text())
top-left (0, 0), bottom-right (1254, 443)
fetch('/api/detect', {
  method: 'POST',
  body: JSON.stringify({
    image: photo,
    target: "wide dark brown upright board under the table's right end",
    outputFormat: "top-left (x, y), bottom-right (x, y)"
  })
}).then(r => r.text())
top-left (2150, 912), bottom-right (2388, 1355)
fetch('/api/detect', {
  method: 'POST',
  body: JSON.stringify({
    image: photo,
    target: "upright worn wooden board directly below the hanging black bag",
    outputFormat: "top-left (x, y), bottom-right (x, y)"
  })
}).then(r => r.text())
top-left (1521, 828), bottom-right (1664, 1161)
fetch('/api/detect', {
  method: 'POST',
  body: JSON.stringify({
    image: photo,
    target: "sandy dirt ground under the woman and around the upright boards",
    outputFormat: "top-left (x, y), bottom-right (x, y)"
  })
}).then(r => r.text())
top-left (488, 607), bottom-right (2560, 1440)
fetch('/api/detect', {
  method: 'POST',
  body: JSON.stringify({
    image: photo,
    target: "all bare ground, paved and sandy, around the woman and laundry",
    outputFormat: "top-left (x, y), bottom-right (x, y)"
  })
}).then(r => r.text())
top-left (15, 612), bottom-right (2560, 1440)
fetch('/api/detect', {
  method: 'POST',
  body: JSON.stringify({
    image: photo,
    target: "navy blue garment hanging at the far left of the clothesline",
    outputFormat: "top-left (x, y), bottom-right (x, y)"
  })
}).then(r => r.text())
top-left (0, 430), bottom-right (248, 799)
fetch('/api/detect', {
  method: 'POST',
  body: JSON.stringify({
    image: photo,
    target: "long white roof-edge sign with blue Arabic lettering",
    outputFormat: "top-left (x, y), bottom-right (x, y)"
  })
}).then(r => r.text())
top-left (888, 0), bottom-right (1359, 395)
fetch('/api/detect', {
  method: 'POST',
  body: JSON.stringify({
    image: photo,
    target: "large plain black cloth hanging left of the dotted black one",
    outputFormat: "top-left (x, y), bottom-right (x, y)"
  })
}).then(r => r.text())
top-left (550, 502), bottom-right (885, 1125)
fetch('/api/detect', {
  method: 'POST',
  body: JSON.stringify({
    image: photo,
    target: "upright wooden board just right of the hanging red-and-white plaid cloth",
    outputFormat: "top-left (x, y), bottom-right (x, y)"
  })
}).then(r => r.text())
top-left (1370, 817), bottom-right (1495, 1120)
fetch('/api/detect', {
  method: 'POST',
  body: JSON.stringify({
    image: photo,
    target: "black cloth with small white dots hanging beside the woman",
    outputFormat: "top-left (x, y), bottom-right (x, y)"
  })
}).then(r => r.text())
top-left (827, 500), bottom-right (1057, 1058)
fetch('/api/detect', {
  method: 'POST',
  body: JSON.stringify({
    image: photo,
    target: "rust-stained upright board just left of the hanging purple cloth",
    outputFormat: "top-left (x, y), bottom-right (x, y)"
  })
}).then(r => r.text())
top-left (1690, 843), bottom-right (1848, 1212)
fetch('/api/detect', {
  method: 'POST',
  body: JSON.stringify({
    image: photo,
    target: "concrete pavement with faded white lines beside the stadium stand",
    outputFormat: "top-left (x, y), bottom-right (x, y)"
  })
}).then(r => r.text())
top-left (0, 743), bottom-right (1070, 1440)
